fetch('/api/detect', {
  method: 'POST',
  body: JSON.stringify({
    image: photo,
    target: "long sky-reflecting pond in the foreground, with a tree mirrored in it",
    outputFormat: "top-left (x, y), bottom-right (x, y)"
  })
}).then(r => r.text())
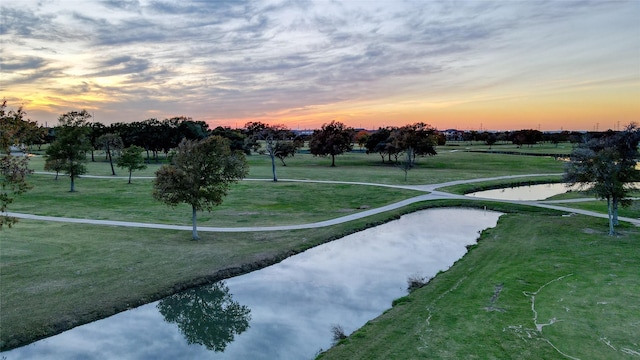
top-left (0, 209), bottom-right (501, 360)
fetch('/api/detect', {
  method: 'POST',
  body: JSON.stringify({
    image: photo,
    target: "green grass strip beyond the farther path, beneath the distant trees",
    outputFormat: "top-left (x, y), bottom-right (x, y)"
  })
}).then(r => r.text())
top-left (31, 150), bottom-right (563, 186)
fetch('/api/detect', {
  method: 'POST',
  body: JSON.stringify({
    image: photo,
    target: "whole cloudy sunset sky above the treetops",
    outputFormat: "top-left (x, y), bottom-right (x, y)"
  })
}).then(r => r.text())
top-left (0, 0), bottom-right (640, 131)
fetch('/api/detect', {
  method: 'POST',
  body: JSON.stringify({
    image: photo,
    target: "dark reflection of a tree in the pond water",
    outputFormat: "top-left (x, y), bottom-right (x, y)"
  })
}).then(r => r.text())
top-left (158, 281), bottom-right (251, 352)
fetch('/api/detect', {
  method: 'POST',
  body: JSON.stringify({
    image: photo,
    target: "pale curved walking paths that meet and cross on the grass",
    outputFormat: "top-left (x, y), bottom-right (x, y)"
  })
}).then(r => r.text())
top-left (7, 172), bottom-right (640, 232)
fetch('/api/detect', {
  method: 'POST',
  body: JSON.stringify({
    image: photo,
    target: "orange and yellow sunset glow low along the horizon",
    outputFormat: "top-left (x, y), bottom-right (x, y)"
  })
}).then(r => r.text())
top-left (7, 75), bottom-right (640, 131)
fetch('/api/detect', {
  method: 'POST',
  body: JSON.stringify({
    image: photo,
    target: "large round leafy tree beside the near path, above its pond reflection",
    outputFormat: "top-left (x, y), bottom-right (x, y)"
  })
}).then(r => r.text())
top-left (153, 136), bottom-right (248, 240)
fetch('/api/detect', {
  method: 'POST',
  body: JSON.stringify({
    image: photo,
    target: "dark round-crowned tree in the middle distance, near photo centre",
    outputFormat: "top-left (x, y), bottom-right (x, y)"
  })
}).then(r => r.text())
top-left (309, 121), bottom-right (355, 167)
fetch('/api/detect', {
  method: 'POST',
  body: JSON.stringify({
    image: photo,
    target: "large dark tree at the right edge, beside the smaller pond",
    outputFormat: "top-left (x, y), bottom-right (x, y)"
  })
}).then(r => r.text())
top-left (564, 123), bottom-right (640, 235)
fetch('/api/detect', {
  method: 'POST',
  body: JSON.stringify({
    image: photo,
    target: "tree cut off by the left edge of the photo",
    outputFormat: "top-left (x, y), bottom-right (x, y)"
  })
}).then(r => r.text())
top-left (0, 101), bottom-right (37, 230)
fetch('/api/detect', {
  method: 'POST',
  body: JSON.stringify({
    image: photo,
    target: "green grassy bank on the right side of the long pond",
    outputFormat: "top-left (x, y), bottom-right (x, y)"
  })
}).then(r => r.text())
top-left (320, 214), bottom-right (640, 359)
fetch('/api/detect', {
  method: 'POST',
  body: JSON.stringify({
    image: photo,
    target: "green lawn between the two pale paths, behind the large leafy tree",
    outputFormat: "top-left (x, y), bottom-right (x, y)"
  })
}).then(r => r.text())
top-left (11, 175), bottom-right (424, 227)
